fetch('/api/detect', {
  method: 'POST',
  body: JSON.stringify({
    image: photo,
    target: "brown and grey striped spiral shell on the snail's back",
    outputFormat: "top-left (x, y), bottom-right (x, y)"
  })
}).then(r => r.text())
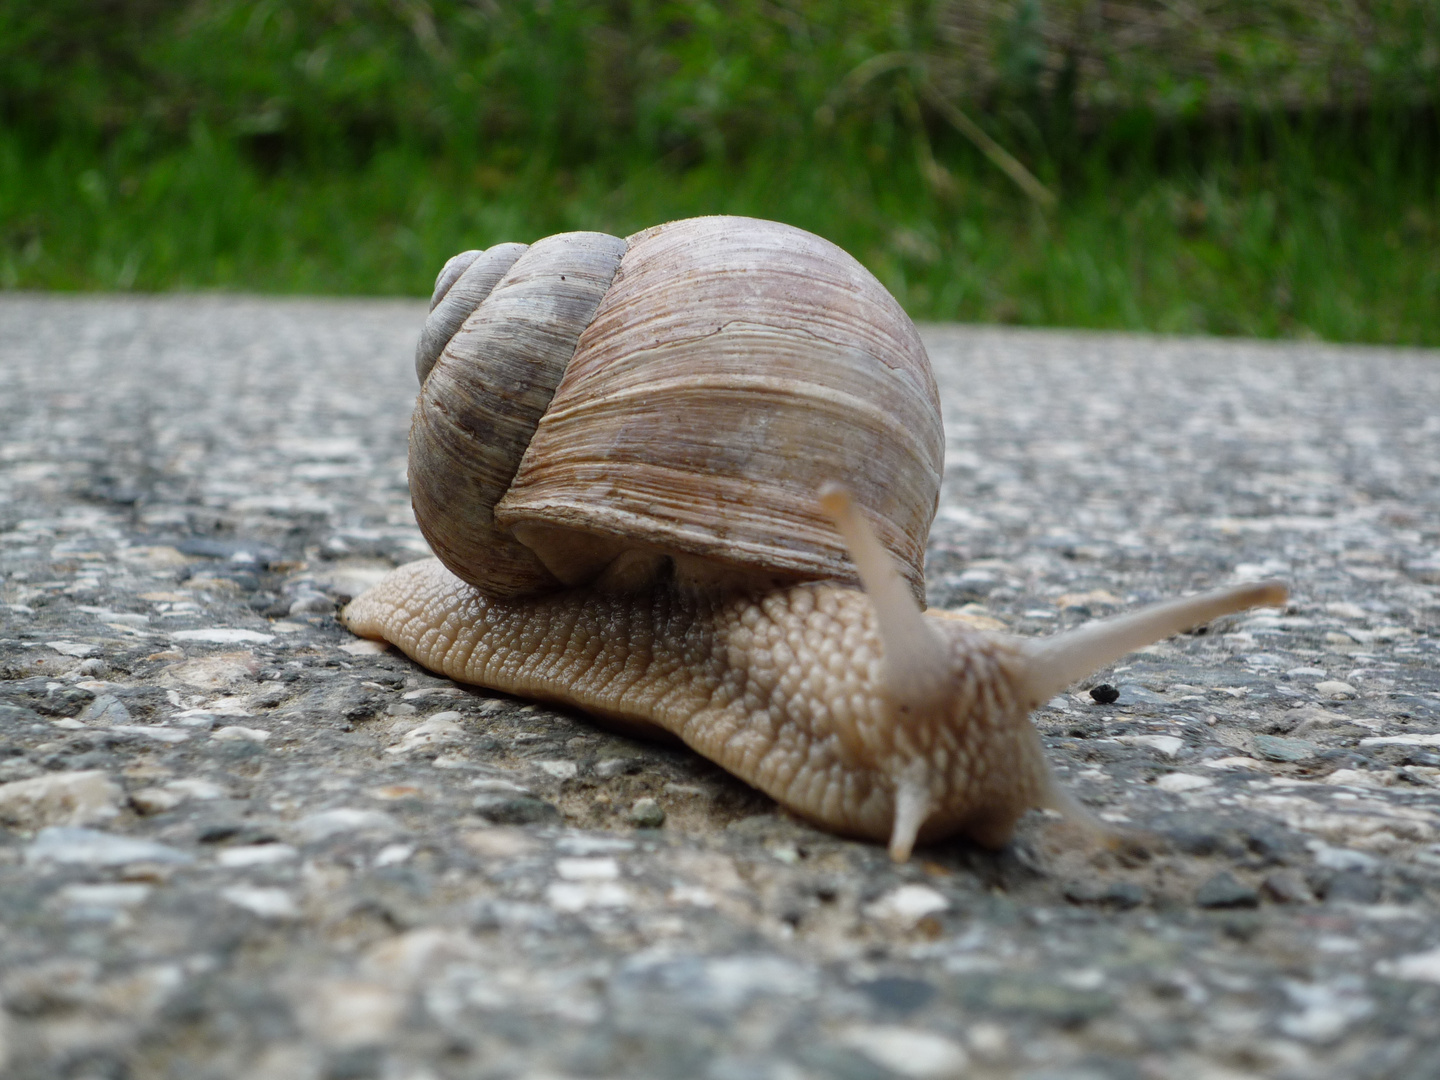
top-left (410, 217), bottom-right (945, 602)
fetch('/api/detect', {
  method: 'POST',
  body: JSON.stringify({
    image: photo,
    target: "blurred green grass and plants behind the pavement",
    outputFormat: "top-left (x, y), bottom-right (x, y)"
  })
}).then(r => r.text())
top-left (0, 0), bottom-right (1440, 344)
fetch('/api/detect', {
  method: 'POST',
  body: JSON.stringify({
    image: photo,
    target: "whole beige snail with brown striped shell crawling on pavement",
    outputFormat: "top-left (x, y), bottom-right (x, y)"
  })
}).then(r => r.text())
top-left (343, 217), bottom-right (1286, 861)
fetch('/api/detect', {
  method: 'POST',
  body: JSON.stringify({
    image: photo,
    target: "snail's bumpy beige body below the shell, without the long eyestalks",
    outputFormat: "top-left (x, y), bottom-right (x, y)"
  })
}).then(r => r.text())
top-left (344, 560), bottom-right (1054, 858)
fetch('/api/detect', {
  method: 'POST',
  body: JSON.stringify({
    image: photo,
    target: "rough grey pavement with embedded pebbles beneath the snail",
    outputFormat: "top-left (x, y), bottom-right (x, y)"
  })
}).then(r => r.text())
top-left (0, 295), bottom-right (1440, 1080)
